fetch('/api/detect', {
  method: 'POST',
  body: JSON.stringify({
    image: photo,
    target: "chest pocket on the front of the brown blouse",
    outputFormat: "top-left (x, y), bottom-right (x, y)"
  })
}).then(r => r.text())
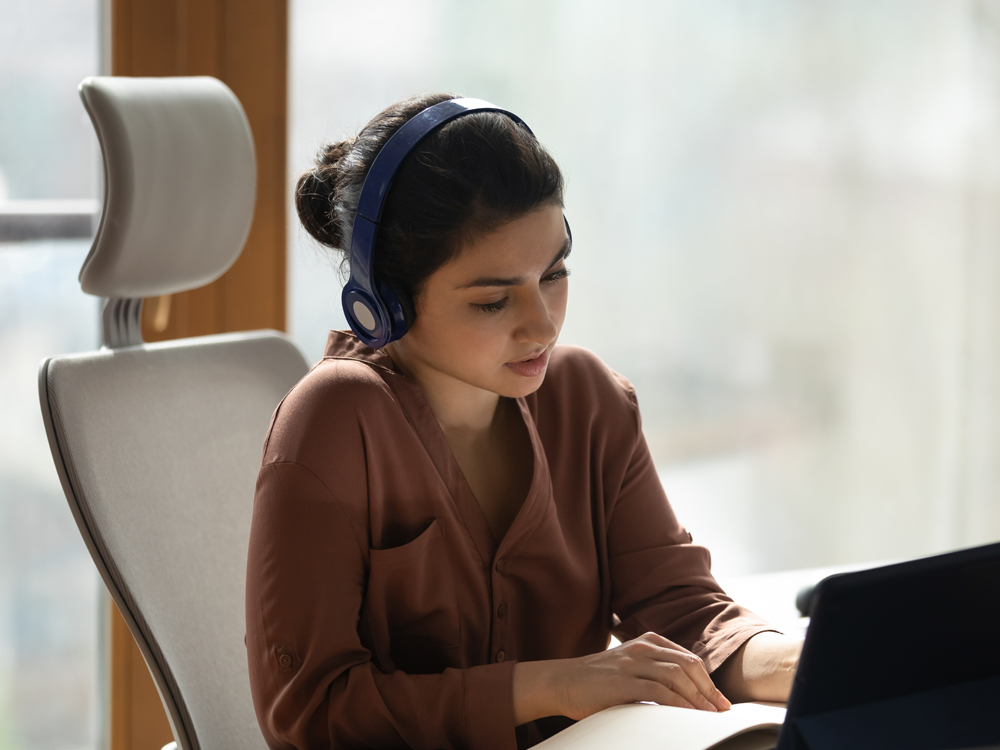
top-left (365, 518), bottom-right (461, 674)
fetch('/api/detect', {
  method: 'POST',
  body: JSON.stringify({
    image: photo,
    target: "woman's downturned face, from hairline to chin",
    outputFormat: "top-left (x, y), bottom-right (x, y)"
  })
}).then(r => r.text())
top-left (397, 206), bottom-right (569, 398)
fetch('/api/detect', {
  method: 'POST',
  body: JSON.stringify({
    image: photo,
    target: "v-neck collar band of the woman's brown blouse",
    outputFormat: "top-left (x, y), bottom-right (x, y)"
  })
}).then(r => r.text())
top-left (324, 331), bottom-right (551, 567)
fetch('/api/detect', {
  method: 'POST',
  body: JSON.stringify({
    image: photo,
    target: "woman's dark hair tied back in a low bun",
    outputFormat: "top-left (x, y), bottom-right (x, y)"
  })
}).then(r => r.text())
top-left (295, 94), bottom-right (563, 308)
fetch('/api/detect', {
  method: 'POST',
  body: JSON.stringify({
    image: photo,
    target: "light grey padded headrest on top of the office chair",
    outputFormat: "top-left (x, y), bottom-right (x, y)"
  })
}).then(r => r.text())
top-left (80, 76), bottom-right (257, 297)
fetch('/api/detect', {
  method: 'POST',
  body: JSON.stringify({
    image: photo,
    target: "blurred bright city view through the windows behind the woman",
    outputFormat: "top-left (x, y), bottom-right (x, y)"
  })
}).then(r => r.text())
top-left (0, 0), bottom-right (1000, 750)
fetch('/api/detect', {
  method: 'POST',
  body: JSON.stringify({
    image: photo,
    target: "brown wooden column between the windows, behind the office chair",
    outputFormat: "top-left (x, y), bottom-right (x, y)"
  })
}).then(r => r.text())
top-left (110, 0), bottom-right (288, 750)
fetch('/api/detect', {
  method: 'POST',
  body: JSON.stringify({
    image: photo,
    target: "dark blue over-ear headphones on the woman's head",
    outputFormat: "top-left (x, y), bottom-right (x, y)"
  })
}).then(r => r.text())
top-left (341, 99), bottom-right (569, 349)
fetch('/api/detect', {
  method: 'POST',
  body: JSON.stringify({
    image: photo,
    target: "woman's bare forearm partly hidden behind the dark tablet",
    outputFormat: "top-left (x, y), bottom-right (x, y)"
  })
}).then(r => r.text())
top-left (712, 632), bottom-right (802, 703)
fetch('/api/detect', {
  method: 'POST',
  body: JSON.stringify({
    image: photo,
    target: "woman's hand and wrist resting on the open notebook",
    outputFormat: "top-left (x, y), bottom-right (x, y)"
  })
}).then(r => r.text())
top-left (514, 633), bottom-right (730, 724)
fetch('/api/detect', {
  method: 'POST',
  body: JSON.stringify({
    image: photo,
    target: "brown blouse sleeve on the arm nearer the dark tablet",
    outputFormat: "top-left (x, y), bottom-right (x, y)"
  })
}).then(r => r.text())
top-left (607, 386), bottom-right (773, 671)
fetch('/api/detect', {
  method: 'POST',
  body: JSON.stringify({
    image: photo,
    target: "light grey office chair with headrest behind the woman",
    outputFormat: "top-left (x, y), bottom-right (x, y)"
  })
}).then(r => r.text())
top-left (39, 77), bottom-right (307, 750)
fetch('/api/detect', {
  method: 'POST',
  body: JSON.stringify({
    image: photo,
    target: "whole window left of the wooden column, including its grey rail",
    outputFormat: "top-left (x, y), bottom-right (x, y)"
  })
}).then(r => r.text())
top-left (0, 0), bottom-right (101, 750)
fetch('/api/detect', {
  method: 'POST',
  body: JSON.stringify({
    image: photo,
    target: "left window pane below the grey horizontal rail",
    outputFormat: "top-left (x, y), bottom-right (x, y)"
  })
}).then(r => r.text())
top-left (0, 241), bottom-right (101, 750)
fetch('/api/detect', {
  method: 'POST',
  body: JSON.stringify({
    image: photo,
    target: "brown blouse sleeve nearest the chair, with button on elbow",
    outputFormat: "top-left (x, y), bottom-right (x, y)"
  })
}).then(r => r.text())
top-left (247, 462), bottom-right (514, 748)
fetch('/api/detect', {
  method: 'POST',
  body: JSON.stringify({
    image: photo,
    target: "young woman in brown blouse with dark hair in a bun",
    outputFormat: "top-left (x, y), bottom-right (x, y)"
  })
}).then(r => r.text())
top-left (247, 95), bottom-right (800, 748)
